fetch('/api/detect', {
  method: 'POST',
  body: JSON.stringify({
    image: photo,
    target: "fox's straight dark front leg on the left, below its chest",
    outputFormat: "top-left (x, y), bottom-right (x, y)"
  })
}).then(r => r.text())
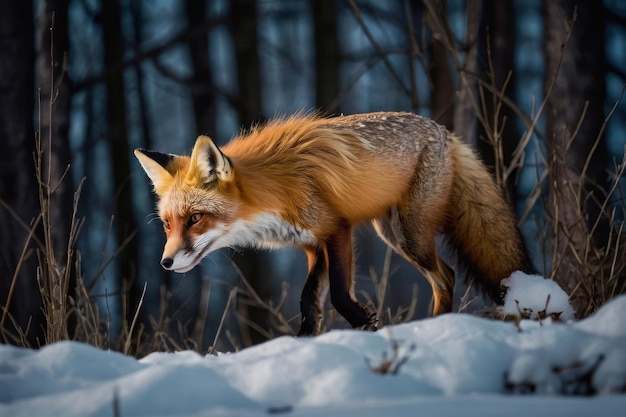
top-left (298, 247), bottom-right (328, 336)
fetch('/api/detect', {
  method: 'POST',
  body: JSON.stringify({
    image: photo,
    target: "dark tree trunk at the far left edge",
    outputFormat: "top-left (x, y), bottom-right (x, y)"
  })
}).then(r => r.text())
top-left (0, 1), bottom-right (45, 346)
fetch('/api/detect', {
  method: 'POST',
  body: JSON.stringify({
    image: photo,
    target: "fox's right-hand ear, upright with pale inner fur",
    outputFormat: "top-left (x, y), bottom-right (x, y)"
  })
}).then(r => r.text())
top-left (187, 135), bottom-right (233, 183)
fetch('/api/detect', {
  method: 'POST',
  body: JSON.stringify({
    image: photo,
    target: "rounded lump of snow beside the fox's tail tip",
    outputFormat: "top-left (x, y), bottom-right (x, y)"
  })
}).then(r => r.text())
top-left (501, 271), bottom-right (575, 321)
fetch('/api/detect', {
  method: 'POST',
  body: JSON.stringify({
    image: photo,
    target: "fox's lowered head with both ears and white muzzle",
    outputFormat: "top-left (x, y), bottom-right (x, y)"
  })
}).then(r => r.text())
top-left (135, 136), bottom-right (238, 272)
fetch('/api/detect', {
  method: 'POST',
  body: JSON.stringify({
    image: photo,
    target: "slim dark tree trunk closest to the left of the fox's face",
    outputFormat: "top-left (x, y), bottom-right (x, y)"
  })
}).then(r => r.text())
top-left (102, 0), bottom-right (141, 334)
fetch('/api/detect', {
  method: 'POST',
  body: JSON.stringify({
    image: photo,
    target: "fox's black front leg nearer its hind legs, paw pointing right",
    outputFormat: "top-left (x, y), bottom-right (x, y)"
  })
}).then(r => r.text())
top-left (326, 222), bottom-right (378, 330)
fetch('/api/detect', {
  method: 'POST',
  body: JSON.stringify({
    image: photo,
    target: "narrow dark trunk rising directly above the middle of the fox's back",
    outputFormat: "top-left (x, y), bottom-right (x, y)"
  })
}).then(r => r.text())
top-left (311, 0), bottom-right (341, 114)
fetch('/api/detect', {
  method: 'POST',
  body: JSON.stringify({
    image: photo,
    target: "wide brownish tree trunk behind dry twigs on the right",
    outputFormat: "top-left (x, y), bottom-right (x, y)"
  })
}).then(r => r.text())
top-left (543, 0), bottom-right (606, 317)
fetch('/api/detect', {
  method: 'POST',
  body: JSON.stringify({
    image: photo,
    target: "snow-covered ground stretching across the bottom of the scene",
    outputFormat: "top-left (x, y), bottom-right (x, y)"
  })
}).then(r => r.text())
top-left (0, 272), bottom-right (626, 417)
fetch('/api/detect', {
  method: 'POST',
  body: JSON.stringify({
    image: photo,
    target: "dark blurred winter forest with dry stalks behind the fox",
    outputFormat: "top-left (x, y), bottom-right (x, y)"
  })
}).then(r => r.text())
top-left (0, 0), bottom-right (626, 355)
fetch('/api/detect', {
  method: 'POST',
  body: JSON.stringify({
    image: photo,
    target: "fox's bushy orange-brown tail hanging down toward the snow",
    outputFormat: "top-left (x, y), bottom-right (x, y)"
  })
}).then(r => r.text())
top-left (445, 138), bottom-right (532, 303)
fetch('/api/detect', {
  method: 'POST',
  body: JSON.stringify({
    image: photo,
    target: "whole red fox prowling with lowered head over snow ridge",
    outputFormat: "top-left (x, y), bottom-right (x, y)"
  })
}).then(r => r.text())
top-left (135, 112), bottom-right (530, 335)
